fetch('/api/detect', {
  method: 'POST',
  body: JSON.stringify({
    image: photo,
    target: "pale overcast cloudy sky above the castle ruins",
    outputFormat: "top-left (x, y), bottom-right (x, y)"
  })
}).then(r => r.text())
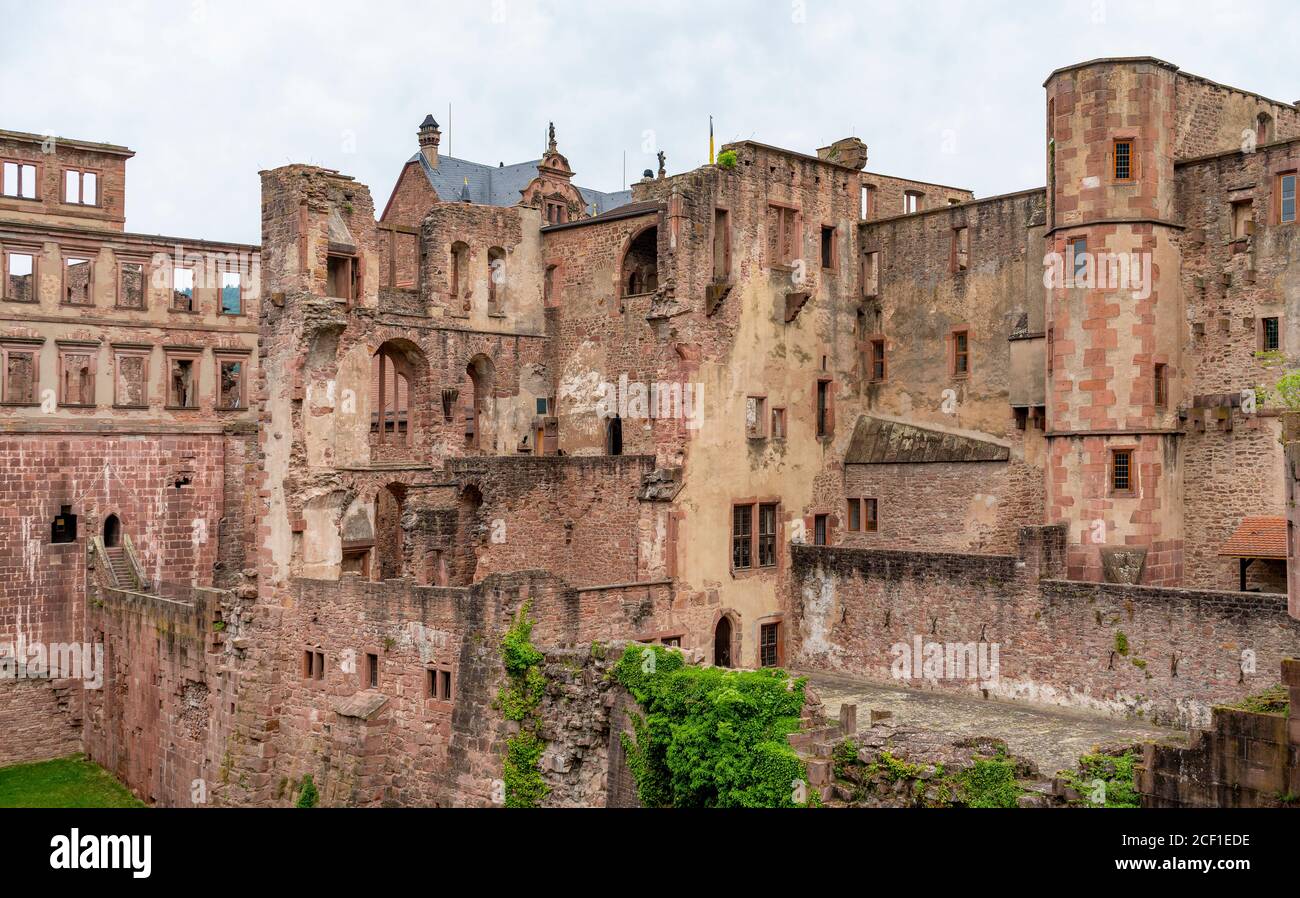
top-left (0, 0), bottom-right (1300, 243)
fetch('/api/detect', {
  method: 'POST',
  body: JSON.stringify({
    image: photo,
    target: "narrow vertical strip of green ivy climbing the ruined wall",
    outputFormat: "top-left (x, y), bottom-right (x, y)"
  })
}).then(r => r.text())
top-left (497, 602), bottom-right (550, 807)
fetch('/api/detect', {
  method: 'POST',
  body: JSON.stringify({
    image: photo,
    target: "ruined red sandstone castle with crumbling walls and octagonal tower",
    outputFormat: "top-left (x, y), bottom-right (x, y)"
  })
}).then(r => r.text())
top-left (0, 58), bottom-right (1300, 804)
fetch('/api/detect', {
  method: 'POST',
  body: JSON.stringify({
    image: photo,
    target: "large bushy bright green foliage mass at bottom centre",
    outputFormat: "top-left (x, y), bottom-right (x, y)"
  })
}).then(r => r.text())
top-left (614, 645), bottom-right (806, 807)
